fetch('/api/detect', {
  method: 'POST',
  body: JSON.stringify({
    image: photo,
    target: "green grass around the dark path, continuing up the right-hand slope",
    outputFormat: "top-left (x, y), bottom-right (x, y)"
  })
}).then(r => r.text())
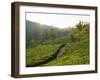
top-left (26, 23), bottom-right (90, 66)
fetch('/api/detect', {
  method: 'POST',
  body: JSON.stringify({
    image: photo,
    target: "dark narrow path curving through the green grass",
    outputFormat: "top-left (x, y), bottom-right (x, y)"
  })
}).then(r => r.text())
top-left (27, 44), bottom-right (65, 67)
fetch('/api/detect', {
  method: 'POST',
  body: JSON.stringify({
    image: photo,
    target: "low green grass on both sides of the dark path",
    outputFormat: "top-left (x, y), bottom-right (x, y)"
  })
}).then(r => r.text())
top-left (26, 39), bottom-right (89, 66)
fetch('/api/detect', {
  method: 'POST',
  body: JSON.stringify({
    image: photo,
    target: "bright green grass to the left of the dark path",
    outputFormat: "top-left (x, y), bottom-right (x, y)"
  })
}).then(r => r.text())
top-left (26, 44), bottom-right (60, 65)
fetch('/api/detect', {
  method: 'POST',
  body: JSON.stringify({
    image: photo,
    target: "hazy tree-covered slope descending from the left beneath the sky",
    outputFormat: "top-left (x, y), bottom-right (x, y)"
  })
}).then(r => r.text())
top-left (26, 21), bottom-right (69, 47)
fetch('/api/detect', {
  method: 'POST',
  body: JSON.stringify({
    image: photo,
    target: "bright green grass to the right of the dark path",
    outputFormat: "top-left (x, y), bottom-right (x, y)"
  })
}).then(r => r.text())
top-left (42, 40), bottom-right (89, 66)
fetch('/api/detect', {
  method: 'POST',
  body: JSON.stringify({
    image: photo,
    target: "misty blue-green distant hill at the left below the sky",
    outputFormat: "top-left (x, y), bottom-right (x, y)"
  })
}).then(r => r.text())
top-left (26, 20), bottom-right (64, 46)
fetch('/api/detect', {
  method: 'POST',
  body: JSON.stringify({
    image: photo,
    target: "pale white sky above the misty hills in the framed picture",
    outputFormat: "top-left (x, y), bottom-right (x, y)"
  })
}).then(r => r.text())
top-left (26, 13), bottom-right (89, 28)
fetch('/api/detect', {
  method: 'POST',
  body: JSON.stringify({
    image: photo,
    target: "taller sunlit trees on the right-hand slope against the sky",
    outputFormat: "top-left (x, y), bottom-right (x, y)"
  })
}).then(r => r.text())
top-left (70, 21), bottom-right (89, 42)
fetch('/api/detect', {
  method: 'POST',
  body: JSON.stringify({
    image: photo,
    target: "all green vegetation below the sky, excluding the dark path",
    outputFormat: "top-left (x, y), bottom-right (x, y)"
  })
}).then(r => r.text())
top-left (26, 21), bottom-right (89, 66)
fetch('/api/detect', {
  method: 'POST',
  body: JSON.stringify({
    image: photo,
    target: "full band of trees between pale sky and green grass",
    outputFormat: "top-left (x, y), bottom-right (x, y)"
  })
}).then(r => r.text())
top-left (26, 21), bottom-right (89, 48)
